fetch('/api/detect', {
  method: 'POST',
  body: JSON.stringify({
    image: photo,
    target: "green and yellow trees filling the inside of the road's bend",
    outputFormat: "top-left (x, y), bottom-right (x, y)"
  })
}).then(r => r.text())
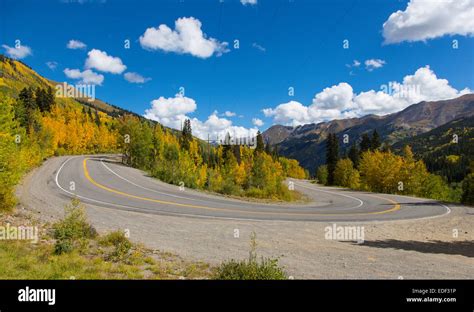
top-left (120, 116), bottom-right (307, 201)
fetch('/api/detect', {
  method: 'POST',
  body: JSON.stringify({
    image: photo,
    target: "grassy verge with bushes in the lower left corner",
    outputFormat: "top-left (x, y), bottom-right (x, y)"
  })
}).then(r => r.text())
top-left (0, 200), bottom-right (213, 279)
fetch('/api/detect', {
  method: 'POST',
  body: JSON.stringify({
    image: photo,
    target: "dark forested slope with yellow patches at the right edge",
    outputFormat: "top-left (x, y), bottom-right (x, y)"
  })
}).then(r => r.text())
top-left (393, 116), bottom-right (474, 182)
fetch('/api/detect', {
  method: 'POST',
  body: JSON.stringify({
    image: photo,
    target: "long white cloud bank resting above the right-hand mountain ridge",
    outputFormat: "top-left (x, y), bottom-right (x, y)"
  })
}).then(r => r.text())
top-left (263, 66), bottom-right (472, 126)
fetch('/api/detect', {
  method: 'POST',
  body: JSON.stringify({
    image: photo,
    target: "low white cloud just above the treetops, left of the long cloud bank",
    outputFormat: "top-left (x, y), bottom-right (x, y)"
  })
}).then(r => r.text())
top-left (144, 94), bottom-right (258, 140)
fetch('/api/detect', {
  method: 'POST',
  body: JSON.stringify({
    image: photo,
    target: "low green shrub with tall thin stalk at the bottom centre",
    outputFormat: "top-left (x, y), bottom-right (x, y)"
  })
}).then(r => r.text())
top-left (215, 233), bottom-right (287, 280)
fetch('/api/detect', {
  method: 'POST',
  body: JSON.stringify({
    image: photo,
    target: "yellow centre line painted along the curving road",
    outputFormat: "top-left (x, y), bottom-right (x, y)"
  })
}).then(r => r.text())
top-left (82, 158), bottom-right (400, 216)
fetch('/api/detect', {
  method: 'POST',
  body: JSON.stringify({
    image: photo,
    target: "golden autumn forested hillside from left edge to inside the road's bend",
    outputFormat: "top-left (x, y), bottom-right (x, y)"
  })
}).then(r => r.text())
top-left (0, 56), bottom-right (306, 210)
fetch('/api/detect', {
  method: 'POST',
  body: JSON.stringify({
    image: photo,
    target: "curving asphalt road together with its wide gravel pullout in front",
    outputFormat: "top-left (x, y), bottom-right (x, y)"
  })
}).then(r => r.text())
top-left (17, 156), bottom-right (474, 279)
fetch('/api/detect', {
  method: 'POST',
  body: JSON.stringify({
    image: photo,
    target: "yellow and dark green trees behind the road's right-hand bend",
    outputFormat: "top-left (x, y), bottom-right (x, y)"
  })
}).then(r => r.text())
top-left (316, 131), bottom-right (474, 205)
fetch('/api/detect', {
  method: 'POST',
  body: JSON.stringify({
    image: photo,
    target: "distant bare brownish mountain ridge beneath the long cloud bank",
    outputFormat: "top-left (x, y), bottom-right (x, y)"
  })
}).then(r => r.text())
top-left (263, 94), bottom-right (474, 173)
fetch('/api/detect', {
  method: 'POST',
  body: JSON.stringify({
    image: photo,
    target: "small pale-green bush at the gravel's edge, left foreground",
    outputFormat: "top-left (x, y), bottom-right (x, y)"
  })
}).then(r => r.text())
top-left (53, 199), bottom-right (97, 254)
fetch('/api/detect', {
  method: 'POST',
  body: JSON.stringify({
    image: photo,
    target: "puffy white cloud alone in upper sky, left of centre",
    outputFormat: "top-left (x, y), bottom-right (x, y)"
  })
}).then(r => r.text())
top-left (140, 17), bottom-right (229, 58)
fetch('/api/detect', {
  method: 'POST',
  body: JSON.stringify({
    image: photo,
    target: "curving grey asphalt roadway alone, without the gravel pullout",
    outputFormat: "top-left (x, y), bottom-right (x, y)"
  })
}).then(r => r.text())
top-left (53, 156), bottom-right (450, 221)
